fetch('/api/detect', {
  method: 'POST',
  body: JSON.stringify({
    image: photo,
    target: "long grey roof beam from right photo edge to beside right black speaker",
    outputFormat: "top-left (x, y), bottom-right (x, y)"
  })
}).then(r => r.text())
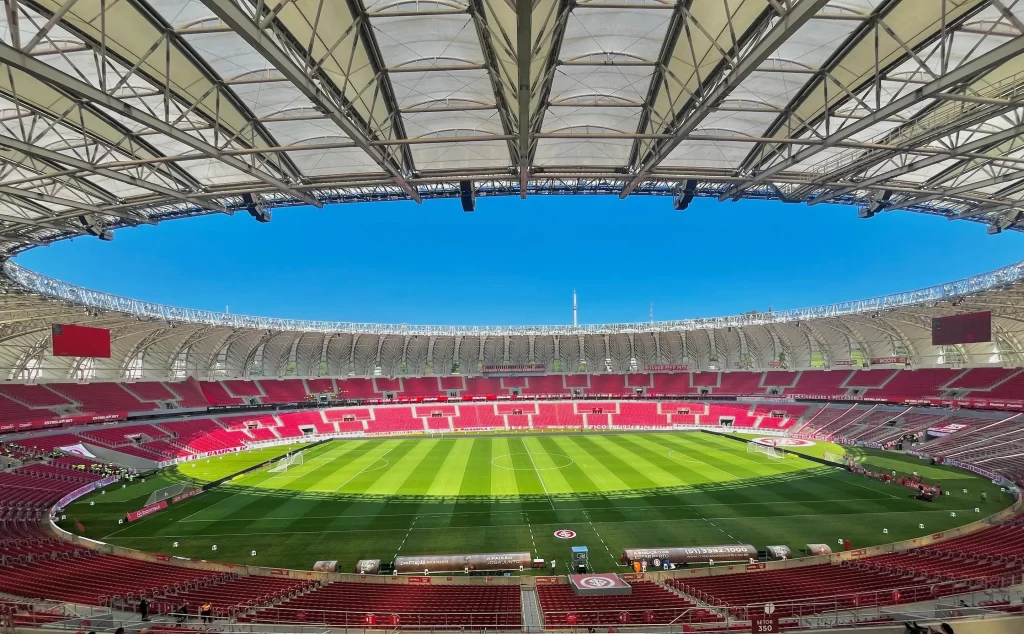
top-left (719, 37), bottom-right (1024, 201)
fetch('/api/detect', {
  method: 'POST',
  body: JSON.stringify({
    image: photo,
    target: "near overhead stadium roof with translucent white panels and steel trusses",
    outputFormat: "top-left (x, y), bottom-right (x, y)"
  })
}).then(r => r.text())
top-left (0, 0), bottom-right (1024, 255)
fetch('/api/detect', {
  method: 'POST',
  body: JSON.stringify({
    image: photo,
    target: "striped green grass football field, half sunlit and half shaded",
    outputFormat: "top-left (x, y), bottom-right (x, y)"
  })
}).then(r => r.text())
top-left (63, 432), bottom-right (1011, 570)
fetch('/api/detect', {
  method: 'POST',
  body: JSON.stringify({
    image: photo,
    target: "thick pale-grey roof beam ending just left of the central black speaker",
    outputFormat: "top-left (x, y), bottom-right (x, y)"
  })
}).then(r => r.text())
top-left (203, 0), bottom-right (422, 203)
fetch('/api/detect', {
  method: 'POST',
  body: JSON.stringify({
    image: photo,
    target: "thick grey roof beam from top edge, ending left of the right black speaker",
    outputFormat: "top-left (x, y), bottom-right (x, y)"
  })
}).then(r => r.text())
top-left (620, 0), bottom-right (828, 198)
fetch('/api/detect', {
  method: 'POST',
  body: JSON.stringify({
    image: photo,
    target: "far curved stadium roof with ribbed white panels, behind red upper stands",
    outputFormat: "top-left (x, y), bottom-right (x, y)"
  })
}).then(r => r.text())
top-left (0, 261), bottom-right (1024, 381)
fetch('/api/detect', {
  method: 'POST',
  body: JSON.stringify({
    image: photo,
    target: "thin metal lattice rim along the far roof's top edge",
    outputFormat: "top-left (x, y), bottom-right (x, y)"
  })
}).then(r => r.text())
top-left (8, 260), bottom-right (1024, 336)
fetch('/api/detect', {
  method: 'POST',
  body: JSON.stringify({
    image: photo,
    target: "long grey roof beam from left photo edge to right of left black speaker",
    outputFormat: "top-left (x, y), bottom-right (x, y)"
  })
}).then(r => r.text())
top-left (0, 43), bottom-right (322, 207)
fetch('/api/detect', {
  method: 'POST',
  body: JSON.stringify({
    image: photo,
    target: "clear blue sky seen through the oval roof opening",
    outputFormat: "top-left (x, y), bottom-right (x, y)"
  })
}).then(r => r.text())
top-left (16, 196), bottom-right (1024, 325)
